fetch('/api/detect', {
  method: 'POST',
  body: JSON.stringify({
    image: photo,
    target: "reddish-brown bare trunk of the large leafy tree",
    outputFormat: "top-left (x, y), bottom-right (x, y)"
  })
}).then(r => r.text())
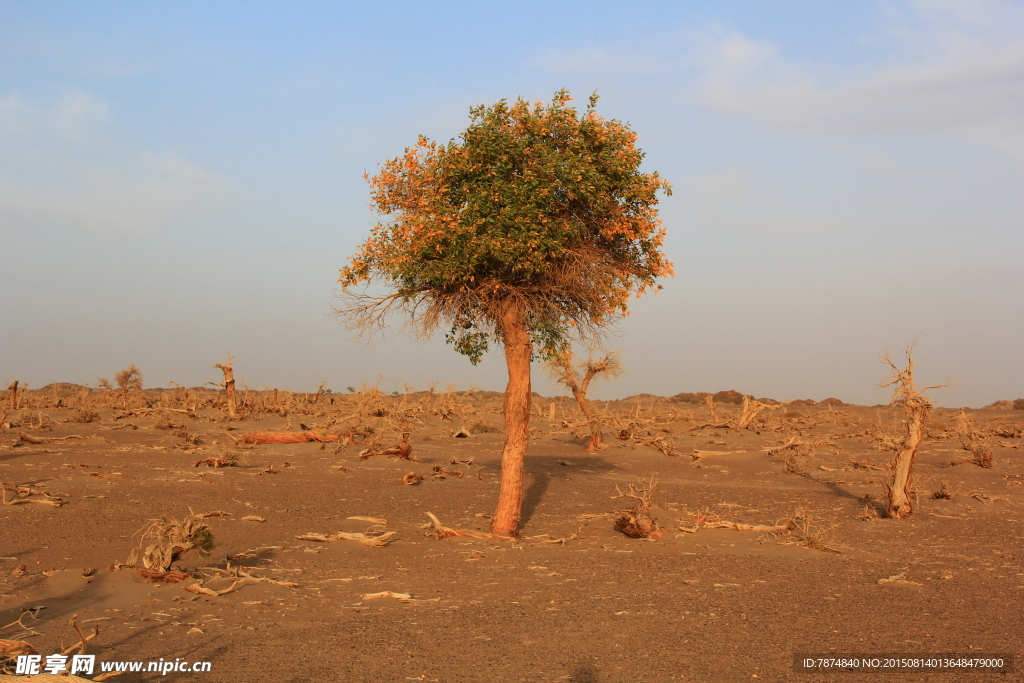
top-left (490, 304), bottom-right (534, 536)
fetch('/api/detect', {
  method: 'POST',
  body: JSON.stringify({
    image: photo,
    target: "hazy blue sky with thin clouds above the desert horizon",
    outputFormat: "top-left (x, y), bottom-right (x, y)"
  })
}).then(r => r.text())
top-left (0, 0), bottom-right (1024, 407)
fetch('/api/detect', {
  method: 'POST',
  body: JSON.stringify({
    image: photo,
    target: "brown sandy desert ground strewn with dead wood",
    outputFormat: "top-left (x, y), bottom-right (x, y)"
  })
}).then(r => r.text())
top-left (0, 394), bottom-right (1024, 683)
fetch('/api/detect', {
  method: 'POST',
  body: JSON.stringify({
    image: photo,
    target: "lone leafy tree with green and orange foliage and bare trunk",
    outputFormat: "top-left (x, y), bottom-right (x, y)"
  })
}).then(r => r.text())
top-left (336, 90), bottom-right (672, 536)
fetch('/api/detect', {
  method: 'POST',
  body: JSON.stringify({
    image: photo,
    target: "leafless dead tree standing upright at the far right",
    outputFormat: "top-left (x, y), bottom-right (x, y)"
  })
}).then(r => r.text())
top-left (879, 343), bottom-right (949, 519)
